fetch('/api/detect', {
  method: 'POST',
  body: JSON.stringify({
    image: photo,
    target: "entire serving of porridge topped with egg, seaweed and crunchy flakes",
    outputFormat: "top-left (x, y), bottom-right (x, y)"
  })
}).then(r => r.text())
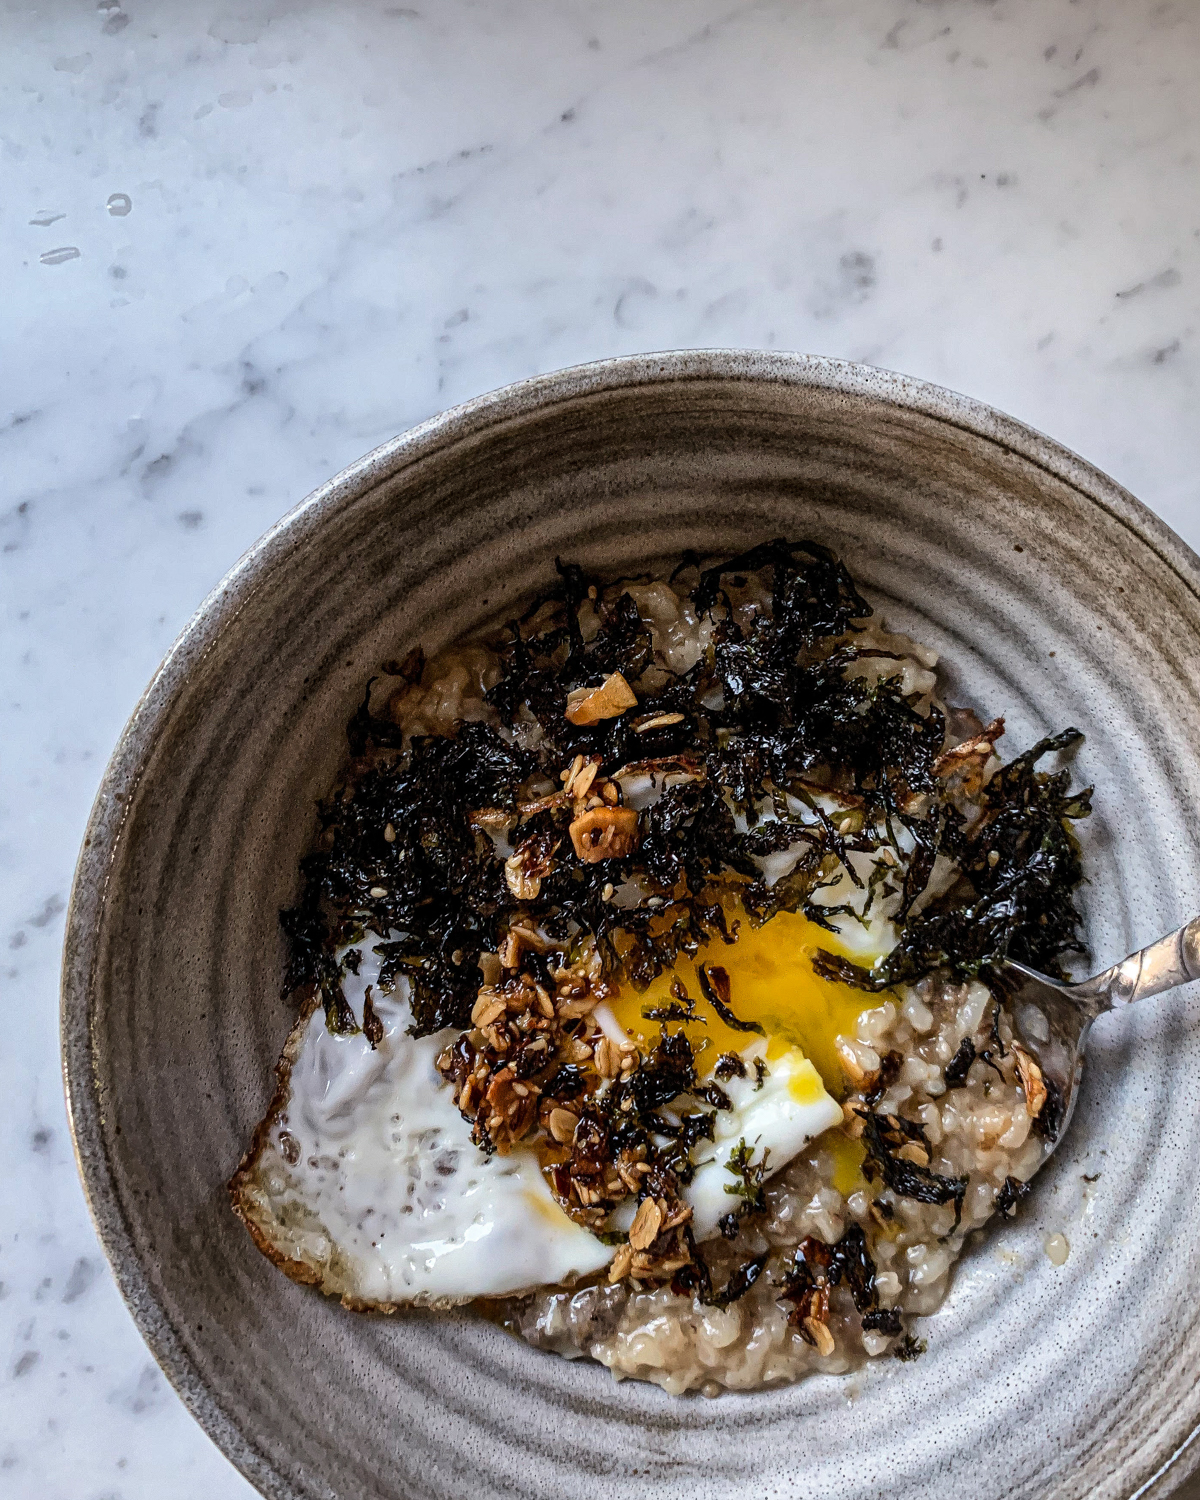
top-left (231, 540), bottom-right (1089, 1394)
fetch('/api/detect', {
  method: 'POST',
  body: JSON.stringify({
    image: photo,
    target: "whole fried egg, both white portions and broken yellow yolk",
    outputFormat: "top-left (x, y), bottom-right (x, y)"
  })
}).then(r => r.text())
top-left (234, 876), bottom-right (879, 1307)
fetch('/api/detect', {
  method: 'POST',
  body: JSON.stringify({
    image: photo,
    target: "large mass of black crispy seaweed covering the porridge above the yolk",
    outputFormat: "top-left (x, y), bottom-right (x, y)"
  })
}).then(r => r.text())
top-left (282, 539), bottom-right (1089, 1056)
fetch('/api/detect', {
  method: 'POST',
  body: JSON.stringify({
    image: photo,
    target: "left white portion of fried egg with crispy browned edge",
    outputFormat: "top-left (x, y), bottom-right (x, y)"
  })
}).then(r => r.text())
top-left (234, 933), bottom-right (612, 1307)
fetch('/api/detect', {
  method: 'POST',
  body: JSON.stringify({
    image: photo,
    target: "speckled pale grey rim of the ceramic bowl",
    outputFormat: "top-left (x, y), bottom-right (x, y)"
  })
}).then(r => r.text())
top-left (59, 348), bottom-right (1200, 1500)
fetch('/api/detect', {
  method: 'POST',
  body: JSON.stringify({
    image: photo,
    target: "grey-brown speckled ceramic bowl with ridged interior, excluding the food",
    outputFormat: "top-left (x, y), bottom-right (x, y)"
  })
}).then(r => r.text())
top-left (62, 353), bottom-right (1200, 1500)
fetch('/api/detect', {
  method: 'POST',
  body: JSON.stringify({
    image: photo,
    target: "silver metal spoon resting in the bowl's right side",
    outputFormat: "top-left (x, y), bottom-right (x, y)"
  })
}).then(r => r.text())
top-left (998, 917), bottom-right (1200, 1157)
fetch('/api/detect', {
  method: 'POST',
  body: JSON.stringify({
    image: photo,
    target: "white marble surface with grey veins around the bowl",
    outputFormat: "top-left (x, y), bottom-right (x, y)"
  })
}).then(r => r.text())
top-left (0, 0), bottom-right (1200, 1500)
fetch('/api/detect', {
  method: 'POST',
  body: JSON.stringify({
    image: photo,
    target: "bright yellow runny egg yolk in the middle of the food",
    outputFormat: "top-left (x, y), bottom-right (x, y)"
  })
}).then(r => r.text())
top-left (609, 912), bottom-right (879, 1103)
